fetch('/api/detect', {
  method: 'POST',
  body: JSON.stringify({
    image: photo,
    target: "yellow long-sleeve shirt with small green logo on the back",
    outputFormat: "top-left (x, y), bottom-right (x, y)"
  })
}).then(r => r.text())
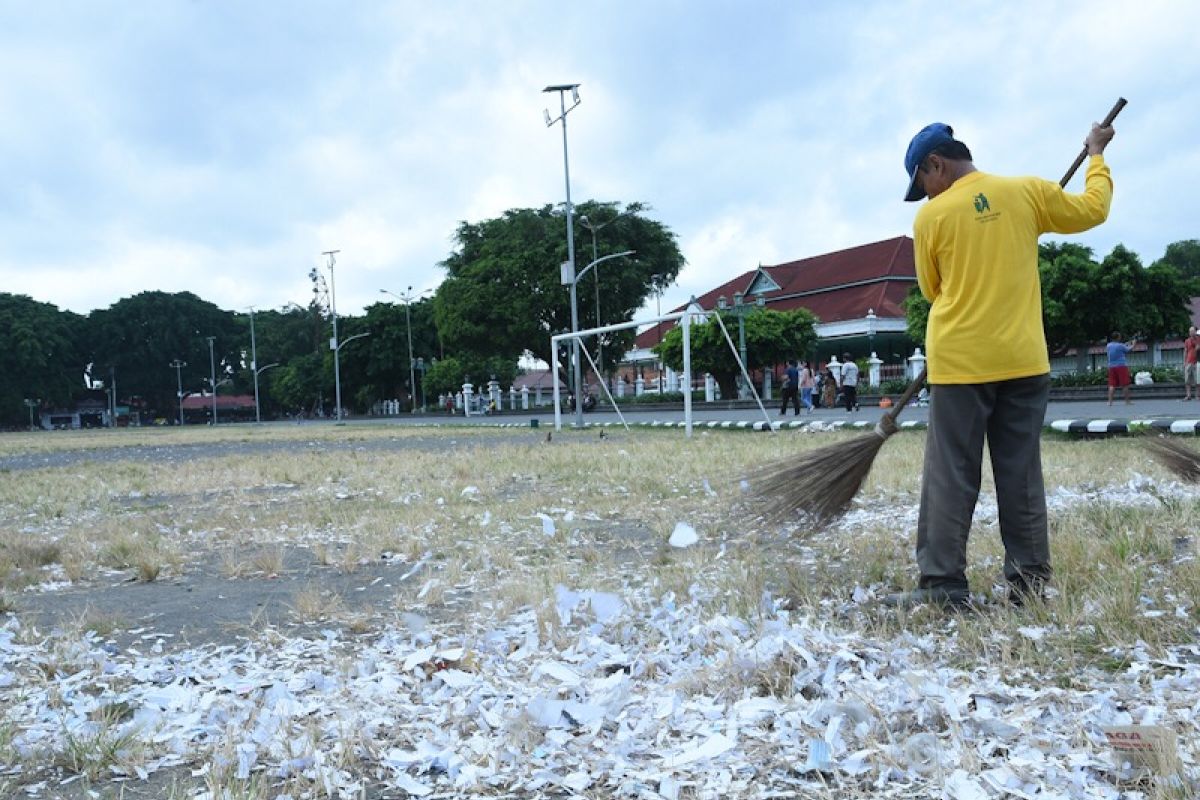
top-left (913, 156), bottom-right (1112, 384)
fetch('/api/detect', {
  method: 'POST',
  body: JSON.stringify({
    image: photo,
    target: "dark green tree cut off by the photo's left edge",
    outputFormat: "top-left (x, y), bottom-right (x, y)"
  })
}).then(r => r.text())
top-left (0, 293), bottom-right (86, 425)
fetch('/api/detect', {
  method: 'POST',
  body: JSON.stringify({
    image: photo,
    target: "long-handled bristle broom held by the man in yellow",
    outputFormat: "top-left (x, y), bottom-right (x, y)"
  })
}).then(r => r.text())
top-left (748, 97), bottom-right (1126, 525)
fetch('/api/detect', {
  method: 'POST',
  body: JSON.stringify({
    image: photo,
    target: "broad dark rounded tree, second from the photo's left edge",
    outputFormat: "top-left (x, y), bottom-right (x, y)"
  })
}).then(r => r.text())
top-left (86, 291), bottom-right (241, 417)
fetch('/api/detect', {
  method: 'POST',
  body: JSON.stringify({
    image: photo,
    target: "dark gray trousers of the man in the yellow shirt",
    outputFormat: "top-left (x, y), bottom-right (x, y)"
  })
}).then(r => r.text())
top-left (917, 375), bottom-right (1050, 589)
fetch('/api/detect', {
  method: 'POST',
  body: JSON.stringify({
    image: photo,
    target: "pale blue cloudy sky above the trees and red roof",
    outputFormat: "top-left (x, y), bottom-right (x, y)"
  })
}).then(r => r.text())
top-left (0, 0), bottom-right (1200, 321)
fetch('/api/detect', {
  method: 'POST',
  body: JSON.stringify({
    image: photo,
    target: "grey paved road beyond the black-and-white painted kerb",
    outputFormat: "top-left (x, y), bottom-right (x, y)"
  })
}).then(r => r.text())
top-left (352, 398), bottom-right (1200, 427)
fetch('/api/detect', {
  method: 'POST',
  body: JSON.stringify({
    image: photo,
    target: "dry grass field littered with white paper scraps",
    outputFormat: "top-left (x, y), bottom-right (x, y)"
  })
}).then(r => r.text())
top-left (0, 426), bottom-right (1200, 800)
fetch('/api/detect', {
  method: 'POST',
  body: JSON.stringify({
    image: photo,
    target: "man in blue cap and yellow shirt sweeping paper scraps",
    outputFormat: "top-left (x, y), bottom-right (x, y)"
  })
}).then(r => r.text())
top-left (887, 122), bottom-right (1114, 606)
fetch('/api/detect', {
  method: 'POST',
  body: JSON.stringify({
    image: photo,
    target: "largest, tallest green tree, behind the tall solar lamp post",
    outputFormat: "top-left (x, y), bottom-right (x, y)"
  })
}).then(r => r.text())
top-left (433, 201), bottom-right (684, 371)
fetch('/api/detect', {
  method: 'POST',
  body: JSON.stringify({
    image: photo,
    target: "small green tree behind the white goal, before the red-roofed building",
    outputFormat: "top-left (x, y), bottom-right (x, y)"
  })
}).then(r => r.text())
top-left (654, 308), bottom-right (817, 397)
